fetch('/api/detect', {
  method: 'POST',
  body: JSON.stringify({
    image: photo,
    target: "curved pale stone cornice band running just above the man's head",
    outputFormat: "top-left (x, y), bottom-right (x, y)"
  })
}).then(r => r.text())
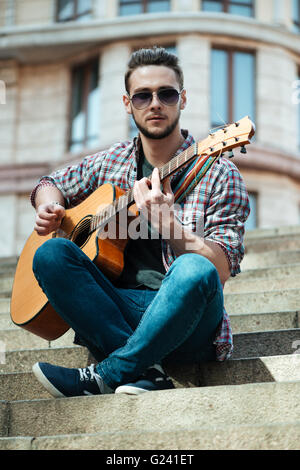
top-left (0, 12), bottom-right (300, 60)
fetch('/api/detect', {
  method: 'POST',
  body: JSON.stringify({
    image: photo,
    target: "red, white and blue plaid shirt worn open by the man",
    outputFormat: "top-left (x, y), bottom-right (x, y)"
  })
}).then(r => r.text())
top-left (31, 131), bottom-right (250, 361)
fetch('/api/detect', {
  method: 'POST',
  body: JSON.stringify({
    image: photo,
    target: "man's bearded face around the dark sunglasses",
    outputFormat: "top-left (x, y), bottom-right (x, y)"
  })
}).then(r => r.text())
top-left (123, 65), bottom-right (186, 139)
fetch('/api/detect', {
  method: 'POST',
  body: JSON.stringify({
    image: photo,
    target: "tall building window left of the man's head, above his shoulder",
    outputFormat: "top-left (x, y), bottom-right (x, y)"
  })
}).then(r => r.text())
top-left (69, 59), bottom-right (100, 153)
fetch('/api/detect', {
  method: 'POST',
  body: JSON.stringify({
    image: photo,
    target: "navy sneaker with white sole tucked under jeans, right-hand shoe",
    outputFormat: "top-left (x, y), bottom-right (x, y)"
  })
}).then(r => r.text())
top-left (115, 364), bottom-right (175, 395)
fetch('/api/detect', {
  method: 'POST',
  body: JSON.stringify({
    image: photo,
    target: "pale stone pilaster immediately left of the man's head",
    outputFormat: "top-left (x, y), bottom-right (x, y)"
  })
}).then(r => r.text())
top-left (99, 43), bottom-right (131, 148)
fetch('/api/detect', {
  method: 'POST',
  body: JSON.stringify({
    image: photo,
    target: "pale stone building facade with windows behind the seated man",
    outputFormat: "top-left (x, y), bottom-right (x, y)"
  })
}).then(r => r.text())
top-left (0, 0), bottom-right (300, 256)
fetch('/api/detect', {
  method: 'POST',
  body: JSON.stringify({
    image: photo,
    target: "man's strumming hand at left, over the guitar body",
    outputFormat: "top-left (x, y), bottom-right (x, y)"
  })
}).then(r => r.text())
top-left (34, 202), bottom-right (66, 236)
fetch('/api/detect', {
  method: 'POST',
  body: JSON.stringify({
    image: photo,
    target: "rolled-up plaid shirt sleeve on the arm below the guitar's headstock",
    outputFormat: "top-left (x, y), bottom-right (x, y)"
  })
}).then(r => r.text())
top-left (204, 166), bottom-right (250, 276)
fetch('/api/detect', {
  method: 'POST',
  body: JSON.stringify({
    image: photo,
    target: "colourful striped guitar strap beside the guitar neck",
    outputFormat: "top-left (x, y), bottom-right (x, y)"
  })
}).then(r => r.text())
top-left (172, 155), bottom-right (220, 204)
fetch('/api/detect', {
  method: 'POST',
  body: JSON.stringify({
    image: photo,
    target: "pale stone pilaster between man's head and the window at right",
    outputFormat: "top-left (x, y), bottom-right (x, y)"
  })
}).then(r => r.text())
top-left (177, 35), bottom-right (210, 139)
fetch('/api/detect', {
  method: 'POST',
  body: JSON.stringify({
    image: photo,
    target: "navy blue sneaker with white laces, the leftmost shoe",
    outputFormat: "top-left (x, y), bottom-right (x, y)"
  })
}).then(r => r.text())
top-left (32, 362), bottom-right (113, 398)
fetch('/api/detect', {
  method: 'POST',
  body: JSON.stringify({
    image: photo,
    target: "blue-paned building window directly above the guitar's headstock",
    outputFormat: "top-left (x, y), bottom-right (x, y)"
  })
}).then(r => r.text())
top-left (211, 49), bottom-right (255, 128)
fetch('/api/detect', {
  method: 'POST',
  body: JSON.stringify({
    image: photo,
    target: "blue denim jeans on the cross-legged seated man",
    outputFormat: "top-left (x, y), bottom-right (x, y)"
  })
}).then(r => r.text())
top-left (33, 239), bottom-right (223, 389)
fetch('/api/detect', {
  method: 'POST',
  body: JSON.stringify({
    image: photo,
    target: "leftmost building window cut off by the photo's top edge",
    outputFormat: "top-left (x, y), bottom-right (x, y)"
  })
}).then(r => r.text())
top-left (56, 0), bottom-right (92, 22)
